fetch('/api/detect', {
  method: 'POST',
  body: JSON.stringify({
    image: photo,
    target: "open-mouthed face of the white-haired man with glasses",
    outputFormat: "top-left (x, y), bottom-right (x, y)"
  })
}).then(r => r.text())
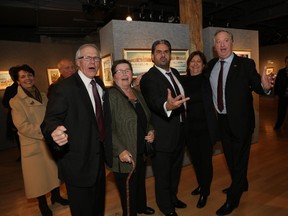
top-left (76, 46), bottom-right (100, 79)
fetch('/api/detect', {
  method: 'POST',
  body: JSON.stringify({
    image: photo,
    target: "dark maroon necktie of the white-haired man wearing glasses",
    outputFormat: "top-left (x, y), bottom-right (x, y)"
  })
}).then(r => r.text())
top-left (90, 80), bottom-right (105, 142)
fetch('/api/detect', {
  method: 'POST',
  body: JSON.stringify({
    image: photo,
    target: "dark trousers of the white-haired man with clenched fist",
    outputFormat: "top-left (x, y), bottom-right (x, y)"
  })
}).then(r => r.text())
top-left (66, 157), bottom-right (106, 216)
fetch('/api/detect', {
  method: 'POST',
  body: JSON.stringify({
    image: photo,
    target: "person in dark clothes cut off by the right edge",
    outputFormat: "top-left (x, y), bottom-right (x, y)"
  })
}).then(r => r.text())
top-left (274, 56), bottom-right (288, 130)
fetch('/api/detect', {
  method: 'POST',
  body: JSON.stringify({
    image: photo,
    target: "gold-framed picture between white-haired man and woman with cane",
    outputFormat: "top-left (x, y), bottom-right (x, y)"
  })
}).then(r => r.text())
top-left (101, 54), bottom-right (113, 87)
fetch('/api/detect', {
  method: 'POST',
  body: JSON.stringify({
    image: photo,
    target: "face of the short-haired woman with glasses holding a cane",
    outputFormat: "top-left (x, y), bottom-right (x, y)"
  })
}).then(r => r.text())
top-left (113, 63), bottom-right (133, 89)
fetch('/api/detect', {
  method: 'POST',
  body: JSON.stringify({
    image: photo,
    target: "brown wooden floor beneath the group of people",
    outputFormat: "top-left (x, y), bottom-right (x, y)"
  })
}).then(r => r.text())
top-left (0, 97), bottom-right (288, 216)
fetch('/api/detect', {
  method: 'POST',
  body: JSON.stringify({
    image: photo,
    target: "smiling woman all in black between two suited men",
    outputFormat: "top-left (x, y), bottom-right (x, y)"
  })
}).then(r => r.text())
top-left (183, 51), bottom-right (218, 208)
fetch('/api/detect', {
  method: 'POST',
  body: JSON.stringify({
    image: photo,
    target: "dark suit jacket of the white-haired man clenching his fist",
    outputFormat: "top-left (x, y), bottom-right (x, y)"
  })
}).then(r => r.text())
top-left (41, 73), bottom-right (112, 187)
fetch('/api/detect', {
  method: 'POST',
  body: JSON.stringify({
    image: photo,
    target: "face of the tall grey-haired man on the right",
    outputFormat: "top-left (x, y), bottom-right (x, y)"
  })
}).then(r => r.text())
top-left (214, 31), bottom-right (233, 59)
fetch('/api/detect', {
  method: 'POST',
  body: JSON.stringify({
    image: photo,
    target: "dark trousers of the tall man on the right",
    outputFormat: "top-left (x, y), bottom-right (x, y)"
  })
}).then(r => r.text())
top-left (218, 115), bottom-right (252, 206)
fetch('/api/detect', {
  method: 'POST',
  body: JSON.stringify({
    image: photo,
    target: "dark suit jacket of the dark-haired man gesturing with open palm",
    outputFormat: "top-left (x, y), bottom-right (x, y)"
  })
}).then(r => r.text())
top-left (140, 67), bottom-right (181, 152)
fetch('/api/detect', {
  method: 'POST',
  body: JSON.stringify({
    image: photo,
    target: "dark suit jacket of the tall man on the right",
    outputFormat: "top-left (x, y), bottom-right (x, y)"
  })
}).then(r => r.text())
top-left (208, 55), bottom-right (265, 137)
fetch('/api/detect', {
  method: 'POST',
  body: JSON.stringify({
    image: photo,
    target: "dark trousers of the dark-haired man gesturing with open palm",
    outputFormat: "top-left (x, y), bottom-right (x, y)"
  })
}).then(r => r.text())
top-left (152, 128), bottom-right (185, 214)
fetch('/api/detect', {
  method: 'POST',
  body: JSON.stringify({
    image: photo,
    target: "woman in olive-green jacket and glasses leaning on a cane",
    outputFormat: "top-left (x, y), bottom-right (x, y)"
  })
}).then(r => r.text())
top-left (109, 59), bottom-right (155, 216)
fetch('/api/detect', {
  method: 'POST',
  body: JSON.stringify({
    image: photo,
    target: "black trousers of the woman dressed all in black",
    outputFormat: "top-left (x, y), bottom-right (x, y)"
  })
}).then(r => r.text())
top-left (187, 129), bottom-right (213, 196)
